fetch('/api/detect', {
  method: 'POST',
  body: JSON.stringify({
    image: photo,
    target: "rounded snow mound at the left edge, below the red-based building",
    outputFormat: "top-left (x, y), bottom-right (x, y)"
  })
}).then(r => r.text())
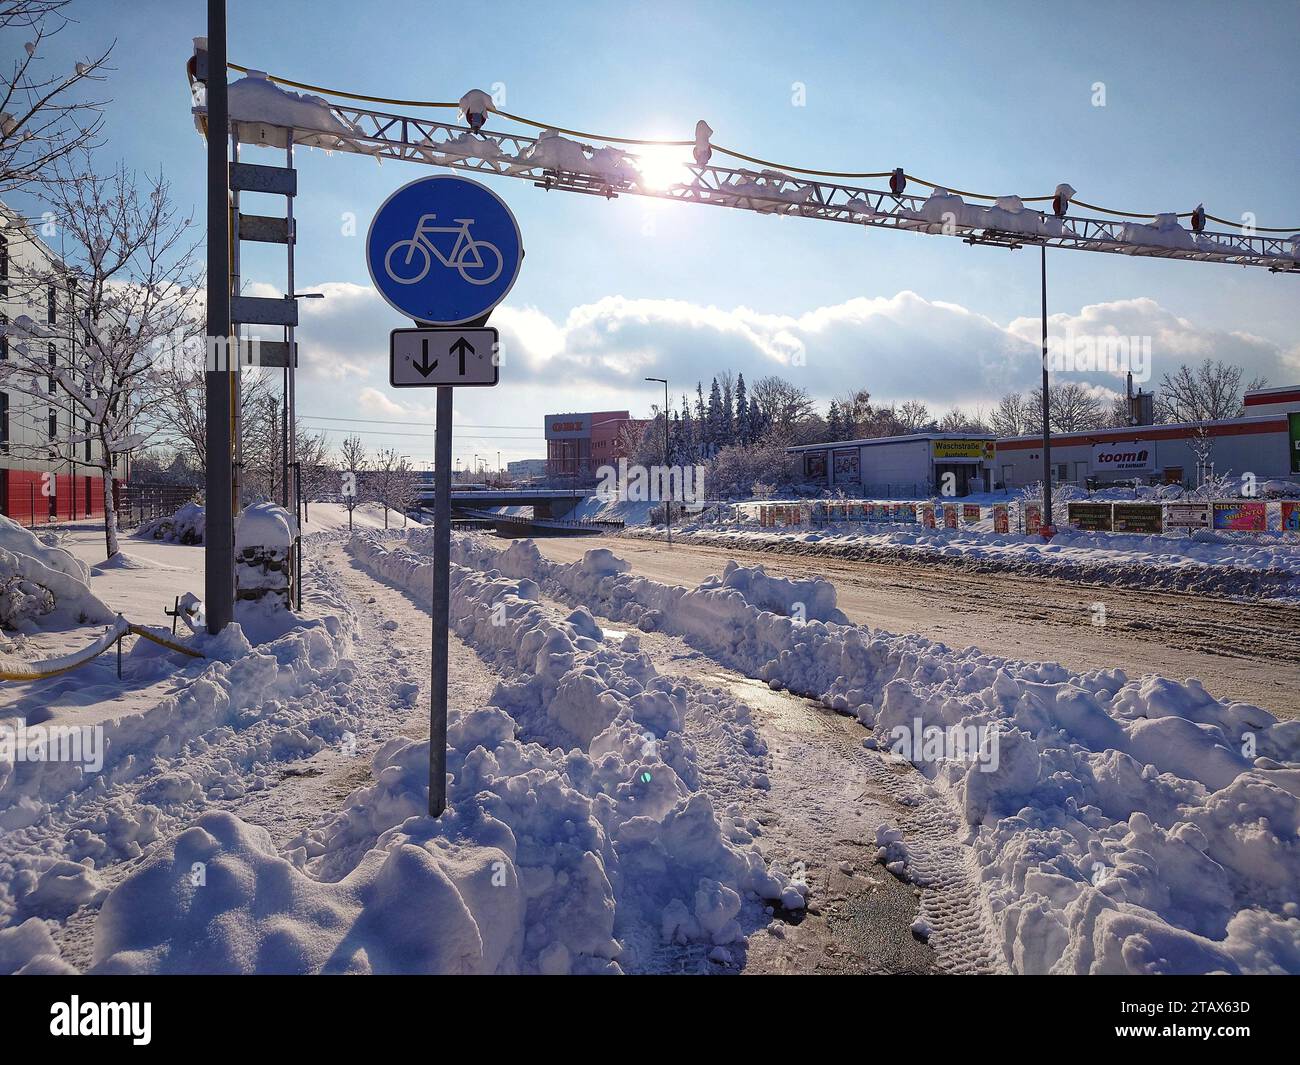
top-left (0, 516), bottom-right (114, 633)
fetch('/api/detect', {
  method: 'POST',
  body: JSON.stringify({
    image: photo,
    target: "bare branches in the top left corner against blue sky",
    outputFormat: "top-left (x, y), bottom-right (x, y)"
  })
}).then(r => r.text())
top-left (0, 0), bottom-right (113, 195)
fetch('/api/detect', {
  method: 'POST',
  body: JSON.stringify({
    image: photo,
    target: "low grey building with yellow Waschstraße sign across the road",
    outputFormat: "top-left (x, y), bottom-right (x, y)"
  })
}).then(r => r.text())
top-left (785, 433), bottom-right (997, 499)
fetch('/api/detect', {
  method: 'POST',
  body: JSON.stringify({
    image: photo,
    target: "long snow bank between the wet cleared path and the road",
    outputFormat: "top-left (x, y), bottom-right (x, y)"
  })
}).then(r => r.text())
top-left (452, 533), bottom-right (1300, 973)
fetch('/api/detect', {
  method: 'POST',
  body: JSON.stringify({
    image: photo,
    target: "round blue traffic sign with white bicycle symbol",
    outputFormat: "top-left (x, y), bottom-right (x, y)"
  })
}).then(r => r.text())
top-left (365, 174), bottom-right (524, 325)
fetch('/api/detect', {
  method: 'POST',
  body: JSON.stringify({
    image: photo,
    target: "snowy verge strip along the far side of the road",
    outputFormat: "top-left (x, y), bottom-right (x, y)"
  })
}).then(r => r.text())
top-left (623, 523), bottom-right (1300, 602)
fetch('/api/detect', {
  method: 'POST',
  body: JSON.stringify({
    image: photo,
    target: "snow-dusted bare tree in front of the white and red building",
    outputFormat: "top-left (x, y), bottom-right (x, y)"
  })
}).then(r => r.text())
top-left (0, 153), bottom-right (196, 558)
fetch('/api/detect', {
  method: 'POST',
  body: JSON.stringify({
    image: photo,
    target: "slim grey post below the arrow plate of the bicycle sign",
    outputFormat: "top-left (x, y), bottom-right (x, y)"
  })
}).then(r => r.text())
top-left (429, 385), bottom-right (452, 817)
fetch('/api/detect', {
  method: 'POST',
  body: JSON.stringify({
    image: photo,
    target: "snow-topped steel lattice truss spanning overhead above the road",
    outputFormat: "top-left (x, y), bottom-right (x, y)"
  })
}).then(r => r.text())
top-left (195, 103), bottom-right (1300, 273)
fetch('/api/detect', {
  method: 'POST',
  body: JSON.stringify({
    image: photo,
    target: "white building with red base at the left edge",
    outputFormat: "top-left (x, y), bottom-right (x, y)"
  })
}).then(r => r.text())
top-left (0, 203), bottom-right (120, 525)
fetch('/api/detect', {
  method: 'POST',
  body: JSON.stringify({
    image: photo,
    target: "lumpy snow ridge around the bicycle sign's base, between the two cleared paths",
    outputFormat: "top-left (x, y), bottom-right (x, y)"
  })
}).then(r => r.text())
top-left (86, 537), bottom-right (803, 973)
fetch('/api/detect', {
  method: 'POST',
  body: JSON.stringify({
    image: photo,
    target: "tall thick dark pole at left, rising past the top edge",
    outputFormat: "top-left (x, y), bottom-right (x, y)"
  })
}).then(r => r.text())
top-left (203, 0), bottom-right (238, 633)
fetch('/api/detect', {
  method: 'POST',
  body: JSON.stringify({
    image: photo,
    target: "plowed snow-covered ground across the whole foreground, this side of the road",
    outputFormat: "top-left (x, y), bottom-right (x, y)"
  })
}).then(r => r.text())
top-left (0, 512), bottom-right (1300, 973)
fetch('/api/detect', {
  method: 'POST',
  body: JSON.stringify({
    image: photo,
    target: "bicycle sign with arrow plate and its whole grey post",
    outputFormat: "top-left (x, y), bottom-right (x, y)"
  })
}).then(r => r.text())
top-left (365, 174), bottom-right (524, 817)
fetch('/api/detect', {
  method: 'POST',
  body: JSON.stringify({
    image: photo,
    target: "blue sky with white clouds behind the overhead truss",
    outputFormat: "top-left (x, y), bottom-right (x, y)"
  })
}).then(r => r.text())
top-left (17, 0), bottom-right (1300, 460)
